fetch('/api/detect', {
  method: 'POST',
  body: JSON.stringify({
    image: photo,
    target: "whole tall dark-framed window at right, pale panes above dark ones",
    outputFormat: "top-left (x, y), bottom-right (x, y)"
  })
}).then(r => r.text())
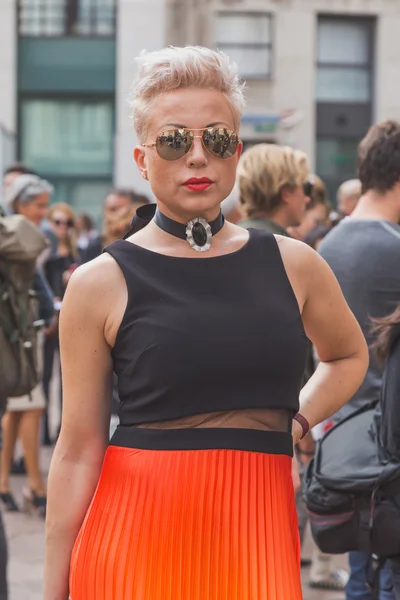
top-left (315, 15), bottom-right (376, 201)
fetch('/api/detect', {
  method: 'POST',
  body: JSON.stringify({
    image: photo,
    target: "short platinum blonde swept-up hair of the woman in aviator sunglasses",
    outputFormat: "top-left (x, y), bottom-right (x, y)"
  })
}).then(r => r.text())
top-left (130, 46), bottom-right (245, 143)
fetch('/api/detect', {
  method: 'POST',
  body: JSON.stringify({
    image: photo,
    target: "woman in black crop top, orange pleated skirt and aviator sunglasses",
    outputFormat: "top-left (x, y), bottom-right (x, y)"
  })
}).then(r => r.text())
top-left (44, 47), bottom-right (367, 600)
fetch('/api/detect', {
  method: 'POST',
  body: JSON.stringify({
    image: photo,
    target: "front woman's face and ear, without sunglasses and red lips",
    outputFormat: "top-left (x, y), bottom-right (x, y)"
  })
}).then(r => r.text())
top-left (135, 88), bottom-right (242, 220)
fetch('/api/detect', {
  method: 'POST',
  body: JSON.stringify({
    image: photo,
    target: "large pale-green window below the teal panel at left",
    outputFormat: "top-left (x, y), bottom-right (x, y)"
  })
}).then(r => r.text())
top-left (19, 98), bottom-right (114, 217)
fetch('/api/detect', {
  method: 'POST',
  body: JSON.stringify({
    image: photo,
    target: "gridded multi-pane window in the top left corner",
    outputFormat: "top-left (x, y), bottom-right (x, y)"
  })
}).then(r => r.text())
top-left (18, 0), bottom-right (116, 36)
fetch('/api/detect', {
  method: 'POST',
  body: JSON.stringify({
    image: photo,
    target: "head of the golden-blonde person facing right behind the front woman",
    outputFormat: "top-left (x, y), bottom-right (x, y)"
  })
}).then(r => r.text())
top-left (238, 144), bottom-right (313, 235)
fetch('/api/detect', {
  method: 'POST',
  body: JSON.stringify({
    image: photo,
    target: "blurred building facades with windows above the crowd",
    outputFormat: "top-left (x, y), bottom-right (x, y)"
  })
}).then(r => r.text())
top-left (0, 0), bottom-right (400, 220)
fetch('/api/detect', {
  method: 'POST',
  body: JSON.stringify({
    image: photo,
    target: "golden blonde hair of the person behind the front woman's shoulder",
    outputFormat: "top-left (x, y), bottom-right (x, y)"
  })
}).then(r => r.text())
top-left (237, 144), bottom-right (309, 217)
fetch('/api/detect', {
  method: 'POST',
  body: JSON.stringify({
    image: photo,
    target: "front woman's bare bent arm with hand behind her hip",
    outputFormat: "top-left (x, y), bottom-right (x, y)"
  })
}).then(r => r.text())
top-left (280, 240), bottom-right (368, 441)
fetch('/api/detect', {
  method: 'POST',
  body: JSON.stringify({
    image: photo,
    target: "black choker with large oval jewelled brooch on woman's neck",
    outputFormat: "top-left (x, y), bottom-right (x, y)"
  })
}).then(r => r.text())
top-left (154, 209), bottom-right (225, 252)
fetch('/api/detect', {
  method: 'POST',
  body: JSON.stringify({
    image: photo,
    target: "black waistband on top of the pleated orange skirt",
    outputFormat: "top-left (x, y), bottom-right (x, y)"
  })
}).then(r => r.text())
top-left (110, 425), bottom-right (293, 456)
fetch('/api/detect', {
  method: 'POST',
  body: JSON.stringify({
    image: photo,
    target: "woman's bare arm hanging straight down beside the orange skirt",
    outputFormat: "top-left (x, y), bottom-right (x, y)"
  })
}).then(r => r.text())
top-left (44, 257), bottom-right (125, 600)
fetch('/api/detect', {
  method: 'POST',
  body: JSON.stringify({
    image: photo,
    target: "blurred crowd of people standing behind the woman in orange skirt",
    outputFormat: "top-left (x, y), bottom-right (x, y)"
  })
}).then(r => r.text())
top-left (0, 116), bottom-right (400, 600)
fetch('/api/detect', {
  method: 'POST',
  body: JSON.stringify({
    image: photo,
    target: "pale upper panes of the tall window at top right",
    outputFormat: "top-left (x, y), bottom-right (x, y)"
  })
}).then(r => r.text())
top-left (316, 17), bottom-right (372, 103)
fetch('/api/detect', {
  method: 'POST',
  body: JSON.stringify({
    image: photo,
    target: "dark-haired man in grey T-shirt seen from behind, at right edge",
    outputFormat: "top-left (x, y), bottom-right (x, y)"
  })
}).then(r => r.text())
top-left (319, 121), bottom-right (400, 600)
